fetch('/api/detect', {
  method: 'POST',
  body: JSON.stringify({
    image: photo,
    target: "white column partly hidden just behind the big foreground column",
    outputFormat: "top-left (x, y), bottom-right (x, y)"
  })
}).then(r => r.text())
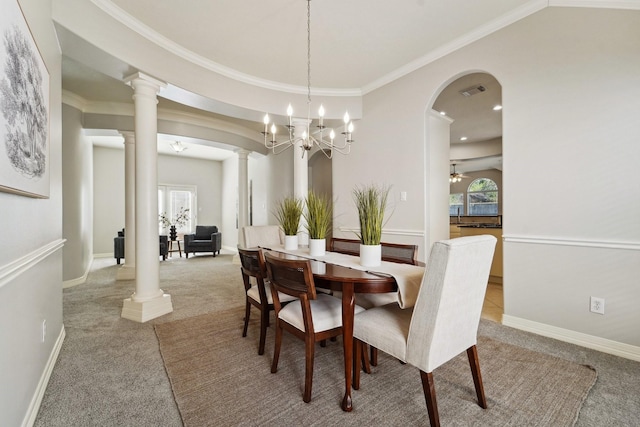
top-left (116, 132), bottom-right (136, 280)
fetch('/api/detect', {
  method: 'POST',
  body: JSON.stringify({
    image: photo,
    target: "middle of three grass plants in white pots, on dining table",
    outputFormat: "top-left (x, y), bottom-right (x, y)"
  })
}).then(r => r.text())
top-left (303, 191), bottom-right (333, 256)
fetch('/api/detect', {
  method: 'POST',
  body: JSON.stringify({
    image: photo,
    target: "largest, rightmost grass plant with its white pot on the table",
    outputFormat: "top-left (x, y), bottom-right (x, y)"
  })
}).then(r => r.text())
top-left (353, 185), bottom-right (390, 267)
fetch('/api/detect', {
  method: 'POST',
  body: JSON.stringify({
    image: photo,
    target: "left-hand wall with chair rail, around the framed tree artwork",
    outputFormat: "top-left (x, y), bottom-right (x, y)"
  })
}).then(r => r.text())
top-left (0, 0), bottom-right (64, 426)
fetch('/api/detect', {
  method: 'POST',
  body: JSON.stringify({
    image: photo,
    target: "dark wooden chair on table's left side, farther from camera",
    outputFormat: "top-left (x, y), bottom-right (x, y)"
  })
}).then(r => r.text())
top-left (238, 248), bottom-right (295, 355)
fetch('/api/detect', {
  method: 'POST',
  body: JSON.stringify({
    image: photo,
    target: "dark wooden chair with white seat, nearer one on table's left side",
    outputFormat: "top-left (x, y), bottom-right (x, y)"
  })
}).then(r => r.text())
top-left (265, 252), bottom-right (364, 403)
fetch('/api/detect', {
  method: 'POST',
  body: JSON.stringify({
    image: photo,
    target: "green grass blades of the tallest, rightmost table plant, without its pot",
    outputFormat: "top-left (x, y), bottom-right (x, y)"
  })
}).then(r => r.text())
top-left (353, 184), bottom-right (390, 245)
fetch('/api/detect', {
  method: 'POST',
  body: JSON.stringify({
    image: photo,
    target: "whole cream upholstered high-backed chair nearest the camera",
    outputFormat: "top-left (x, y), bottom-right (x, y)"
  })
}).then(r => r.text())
top-left (353, 235), bottom-right (496, 426)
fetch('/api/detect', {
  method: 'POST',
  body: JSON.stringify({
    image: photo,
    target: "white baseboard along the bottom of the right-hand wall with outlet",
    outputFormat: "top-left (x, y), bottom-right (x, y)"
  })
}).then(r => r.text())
top-left (502, 314), bottom-right (640, 362)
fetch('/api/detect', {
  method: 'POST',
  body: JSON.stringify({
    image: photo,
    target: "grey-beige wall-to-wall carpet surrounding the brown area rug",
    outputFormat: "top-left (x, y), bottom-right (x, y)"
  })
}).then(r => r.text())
top-left (35, 251), bottom-right (640, 427)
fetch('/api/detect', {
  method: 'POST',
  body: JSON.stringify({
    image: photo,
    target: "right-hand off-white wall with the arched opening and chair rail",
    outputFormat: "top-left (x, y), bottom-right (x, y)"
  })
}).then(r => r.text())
top-left (334, 7), bottom-right (640, 358)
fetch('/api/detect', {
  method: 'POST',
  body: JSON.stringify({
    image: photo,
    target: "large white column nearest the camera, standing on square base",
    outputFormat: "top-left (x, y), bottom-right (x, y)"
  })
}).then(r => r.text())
top-left (122, 73), bottom-right (173, 322)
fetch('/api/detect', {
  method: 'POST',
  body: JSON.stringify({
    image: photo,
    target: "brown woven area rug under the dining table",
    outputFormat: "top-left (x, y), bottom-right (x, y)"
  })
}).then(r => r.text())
top-left (155, 308), bottom-right (596, 427)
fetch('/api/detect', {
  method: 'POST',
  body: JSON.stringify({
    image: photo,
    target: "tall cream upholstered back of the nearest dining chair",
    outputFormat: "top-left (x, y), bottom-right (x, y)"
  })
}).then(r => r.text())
top-left (407, 235), bottom-right (496, 372)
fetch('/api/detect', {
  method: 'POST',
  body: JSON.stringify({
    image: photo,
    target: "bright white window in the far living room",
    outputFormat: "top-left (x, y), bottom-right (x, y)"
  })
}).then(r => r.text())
top-left (158, 185), bottom-right (197, 234)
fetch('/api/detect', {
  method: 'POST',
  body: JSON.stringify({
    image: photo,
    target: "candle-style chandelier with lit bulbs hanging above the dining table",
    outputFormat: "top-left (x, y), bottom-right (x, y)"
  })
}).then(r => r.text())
top-left (262, 0), bottom-right (353, 159)
